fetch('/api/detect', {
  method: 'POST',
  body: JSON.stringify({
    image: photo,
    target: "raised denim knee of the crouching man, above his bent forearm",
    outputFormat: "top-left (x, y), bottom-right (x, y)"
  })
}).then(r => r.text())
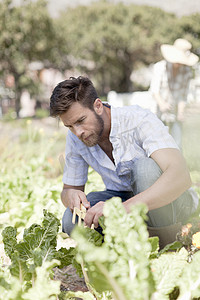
top-left (131, 157), bottom-right (162, 195)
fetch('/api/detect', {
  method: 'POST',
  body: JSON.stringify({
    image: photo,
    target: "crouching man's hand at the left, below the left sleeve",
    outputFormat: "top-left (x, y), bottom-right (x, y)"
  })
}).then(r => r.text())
top-left (61, 184), bottom-right (90, 211)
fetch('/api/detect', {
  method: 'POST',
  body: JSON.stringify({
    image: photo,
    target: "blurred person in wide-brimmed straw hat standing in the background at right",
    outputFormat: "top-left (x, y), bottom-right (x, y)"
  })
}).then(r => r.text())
top-left (150, 39), bottom-right (199, 149)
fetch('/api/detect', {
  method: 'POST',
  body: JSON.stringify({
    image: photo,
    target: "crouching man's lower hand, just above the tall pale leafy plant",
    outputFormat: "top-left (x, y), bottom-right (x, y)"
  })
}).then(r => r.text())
top-left (84, 201), bottom-right (105, 228)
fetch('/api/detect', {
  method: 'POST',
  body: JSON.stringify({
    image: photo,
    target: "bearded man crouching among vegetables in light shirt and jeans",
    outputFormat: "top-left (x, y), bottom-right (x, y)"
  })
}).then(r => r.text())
top-left (50, 76), bottom-right (195, 248)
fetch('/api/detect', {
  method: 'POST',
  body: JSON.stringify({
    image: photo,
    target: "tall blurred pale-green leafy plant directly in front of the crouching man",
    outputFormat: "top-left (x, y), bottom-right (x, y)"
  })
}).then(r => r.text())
top-left (73, 198), bottom-right (154, 300)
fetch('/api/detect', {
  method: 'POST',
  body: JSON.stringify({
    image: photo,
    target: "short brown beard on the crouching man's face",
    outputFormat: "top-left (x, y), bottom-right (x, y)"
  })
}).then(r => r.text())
top-left (80, 112), bottom-right (104, 147)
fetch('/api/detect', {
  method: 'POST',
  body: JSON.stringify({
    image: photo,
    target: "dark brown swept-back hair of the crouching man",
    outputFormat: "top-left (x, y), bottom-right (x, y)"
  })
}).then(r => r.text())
top-left (50, 76), bottom-right (98, 117)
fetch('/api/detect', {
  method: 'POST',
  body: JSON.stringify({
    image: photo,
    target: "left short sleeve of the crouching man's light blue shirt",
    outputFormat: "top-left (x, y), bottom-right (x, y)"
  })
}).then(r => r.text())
top-left (63, 131), bottom-right (88, 186)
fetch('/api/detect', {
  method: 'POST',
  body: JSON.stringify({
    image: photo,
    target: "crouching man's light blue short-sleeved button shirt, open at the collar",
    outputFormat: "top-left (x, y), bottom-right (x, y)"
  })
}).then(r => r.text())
top-left (63, 105), bottom-right (178, 191)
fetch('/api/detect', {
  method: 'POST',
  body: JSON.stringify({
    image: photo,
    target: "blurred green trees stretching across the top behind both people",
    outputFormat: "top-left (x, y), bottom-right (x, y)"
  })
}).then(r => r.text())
top-left (0, 0), bottom-right (200, 104)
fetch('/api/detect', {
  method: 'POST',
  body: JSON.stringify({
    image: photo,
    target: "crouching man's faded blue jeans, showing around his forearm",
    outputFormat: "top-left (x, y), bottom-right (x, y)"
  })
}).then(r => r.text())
top-left (62, 158), bottom-right (195, 235)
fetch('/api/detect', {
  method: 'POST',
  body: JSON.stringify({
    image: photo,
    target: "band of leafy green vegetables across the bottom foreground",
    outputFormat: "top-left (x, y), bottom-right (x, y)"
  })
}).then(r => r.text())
top-left (0, 198), bottom-right (200, 300)
